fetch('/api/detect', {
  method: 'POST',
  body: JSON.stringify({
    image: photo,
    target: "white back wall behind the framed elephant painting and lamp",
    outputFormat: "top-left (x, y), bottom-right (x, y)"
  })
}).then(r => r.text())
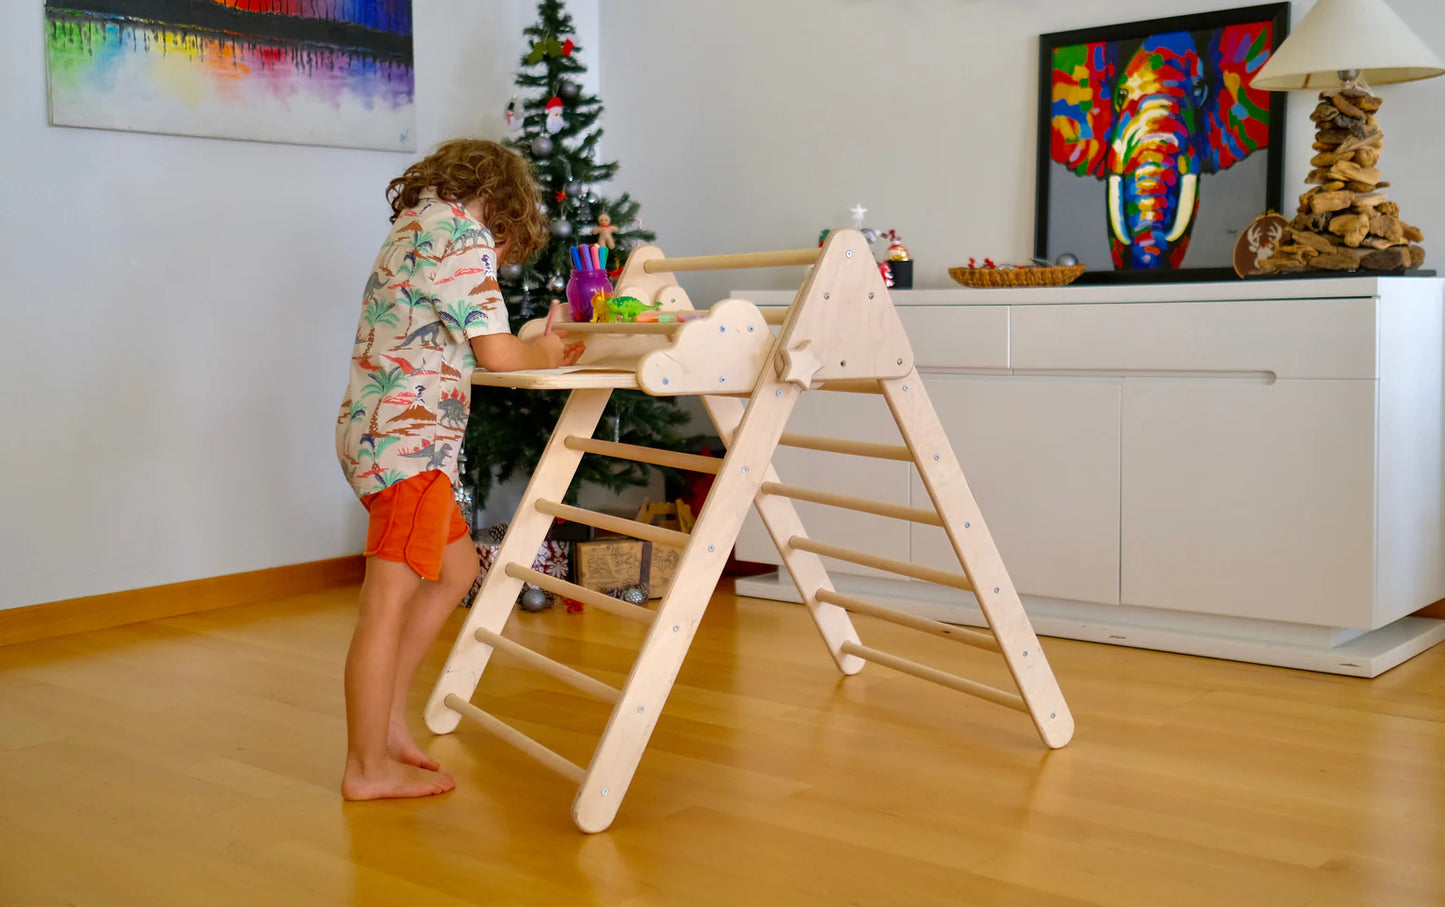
top-left (603, 0), bottom-right (1445, 303)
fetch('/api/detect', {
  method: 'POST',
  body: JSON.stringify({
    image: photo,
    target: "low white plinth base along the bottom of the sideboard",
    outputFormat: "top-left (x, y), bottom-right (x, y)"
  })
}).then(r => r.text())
top-left (737, 570), bottom-right (1445, 677)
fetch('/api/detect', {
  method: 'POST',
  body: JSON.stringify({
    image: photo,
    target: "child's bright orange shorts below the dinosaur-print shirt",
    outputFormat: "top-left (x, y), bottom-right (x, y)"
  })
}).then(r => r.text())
top-left (361, 469), bottom-right (468, 581)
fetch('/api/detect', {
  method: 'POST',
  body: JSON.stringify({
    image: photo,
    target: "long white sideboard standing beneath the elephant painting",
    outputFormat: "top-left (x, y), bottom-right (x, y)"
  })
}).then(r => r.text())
top-left (733, 277), bottom-right (1445, 677)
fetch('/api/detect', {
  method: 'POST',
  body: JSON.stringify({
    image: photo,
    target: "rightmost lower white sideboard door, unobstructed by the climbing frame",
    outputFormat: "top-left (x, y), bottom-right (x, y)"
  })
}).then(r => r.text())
top-left (1121, 378), bottom-right (1376, 627)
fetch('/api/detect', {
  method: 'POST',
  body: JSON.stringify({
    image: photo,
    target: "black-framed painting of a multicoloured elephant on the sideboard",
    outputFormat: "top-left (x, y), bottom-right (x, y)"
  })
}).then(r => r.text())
top-left (1036, 3), bottom-right (1289, 280)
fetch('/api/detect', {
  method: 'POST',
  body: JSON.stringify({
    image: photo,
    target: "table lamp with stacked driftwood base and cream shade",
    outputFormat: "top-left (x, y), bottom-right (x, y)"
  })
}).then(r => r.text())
top-left (1251, 0), bottom-right (1445, 273)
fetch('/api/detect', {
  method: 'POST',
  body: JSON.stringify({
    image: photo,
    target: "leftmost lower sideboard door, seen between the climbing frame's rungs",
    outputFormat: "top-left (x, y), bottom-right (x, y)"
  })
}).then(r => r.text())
top-left (737, 391), bottom-right (913, 576)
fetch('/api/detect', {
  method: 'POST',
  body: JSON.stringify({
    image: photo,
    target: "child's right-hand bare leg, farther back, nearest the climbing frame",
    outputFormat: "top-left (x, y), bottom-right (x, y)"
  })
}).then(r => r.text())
top-left (389, 536), bottom-right (480, 771)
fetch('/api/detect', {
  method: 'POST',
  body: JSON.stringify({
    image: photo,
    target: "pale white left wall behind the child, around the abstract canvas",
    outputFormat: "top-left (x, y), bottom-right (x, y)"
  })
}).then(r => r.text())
top-left (0, 0), bottom-right (598, 608)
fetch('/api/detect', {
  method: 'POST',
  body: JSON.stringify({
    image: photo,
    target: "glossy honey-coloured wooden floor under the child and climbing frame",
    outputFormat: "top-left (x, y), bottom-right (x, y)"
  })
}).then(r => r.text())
top-left (0, 580), bottom-right (1445, 907)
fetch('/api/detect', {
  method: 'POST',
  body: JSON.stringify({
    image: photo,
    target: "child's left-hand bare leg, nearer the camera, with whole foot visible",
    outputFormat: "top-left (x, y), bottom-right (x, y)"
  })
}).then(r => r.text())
top-left (341, 557), bottom-right (455, 800)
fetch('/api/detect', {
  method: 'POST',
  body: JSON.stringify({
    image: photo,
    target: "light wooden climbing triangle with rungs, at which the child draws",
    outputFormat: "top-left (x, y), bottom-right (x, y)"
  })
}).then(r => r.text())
top-left (426, 230), bottom-right (1074, 832)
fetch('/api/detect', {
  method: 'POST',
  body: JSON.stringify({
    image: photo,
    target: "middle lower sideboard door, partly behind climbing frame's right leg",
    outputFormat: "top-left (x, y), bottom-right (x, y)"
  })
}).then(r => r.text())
top-left (909, 374), bottom-right (1120, 604)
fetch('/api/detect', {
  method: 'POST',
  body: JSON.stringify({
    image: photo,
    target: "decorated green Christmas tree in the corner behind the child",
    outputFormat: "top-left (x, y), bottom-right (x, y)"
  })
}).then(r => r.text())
top-left (461, 0), bottom-right (695, 508)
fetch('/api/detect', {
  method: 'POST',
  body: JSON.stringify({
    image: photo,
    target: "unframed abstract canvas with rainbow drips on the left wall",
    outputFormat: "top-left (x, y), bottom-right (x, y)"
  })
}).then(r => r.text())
top-left (45, 0), bottom-right (416, 152)
